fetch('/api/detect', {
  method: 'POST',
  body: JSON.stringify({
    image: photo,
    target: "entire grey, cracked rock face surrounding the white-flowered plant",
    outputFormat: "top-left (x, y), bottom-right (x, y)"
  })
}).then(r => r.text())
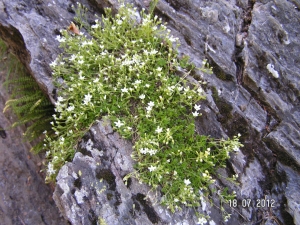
top-left (0, 0), bottom-right (300, 224)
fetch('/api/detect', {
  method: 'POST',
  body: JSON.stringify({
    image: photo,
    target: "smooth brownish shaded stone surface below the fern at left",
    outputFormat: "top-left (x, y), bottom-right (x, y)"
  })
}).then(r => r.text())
top-left (0, 61), bottom-right (67, 225)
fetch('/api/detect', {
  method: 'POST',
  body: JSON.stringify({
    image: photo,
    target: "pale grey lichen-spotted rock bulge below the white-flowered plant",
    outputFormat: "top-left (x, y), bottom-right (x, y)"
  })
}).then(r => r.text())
top-left (54, 121), bottom-right (231, 225)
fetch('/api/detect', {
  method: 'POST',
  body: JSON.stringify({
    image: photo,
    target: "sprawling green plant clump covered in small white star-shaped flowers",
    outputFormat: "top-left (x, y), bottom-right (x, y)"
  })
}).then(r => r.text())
top-left (46, 1), bottom-right (242, 222)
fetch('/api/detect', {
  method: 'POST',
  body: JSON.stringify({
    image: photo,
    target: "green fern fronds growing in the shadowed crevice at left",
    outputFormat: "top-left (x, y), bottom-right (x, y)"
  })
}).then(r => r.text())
top-left (0, 40), bottom-right (54, 153)
